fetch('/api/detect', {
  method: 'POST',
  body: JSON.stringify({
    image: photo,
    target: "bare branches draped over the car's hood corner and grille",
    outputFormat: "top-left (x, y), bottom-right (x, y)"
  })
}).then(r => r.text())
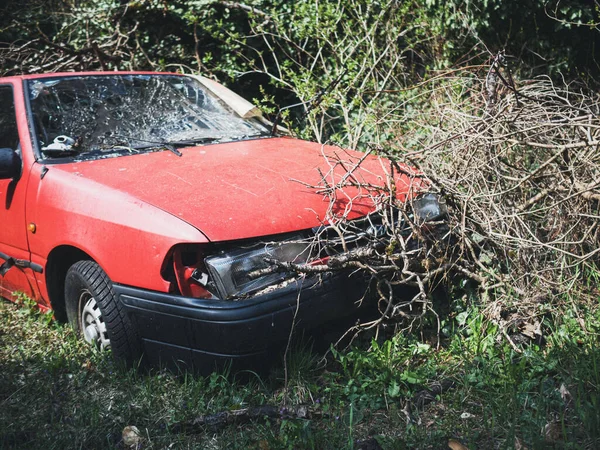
top-left (286, 148), bottom-right (452, 328)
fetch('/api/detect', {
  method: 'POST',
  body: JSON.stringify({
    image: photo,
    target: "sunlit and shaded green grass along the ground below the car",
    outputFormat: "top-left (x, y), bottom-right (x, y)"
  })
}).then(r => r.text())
top-left (0, 297), bottom-right (600, 450)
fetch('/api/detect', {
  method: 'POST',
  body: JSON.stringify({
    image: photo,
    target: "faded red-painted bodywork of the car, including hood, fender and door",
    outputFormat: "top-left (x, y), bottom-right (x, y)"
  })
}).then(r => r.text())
top-left (0, 72), bottom-right (418, 305)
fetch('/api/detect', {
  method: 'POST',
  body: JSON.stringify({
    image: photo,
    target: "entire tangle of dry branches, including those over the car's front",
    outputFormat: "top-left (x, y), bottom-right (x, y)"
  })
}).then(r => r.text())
top-left (268, 58), bottom-right (600, 336)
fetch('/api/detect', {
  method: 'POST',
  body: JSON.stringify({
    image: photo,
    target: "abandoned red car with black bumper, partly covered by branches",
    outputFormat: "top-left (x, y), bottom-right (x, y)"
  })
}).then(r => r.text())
top-left (0, 72), bottom-right (439, 368)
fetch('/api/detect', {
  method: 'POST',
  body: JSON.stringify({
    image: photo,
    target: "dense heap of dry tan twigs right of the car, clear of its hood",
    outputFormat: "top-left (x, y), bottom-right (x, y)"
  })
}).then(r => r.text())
top-left (414, 67), bottom-right (600, 298)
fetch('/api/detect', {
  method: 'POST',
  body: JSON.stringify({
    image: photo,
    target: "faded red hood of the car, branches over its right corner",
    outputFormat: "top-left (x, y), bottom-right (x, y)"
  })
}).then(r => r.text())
top-left (52, 138), bottom-right (422, 241)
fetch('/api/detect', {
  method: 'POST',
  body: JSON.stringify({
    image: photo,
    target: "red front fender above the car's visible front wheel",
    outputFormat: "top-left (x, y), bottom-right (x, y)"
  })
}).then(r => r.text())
top-left (26, 164), bottom-right (208, 292)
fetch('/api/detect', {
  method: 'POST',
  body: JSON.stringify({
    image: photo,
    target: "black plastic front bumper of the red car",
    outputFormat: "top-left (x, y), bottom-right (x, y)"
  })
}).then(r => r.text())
top-left (114, 274), bottom-right (368, 371)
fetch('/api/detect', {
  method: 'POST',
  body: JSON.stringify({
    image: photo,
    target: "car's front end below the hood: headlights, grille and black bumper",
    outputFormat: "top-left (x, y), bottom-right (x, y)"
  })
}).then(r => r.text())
top-left (114, 194), bottom-right (447, 370)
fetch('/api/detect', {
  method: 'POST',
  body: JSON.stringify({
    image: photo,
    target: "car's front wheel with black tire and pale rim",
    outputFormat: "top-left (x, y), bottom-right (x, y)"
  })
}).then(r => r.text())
top-left (65, 261), bottom-right (142, 366)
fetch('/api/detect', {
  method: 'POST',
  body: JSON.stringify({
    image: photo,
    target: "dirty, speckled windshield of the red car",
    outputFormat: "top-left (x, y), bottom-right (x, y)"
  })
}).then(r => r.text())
top-left (28, 75), bottom-right (269, 159)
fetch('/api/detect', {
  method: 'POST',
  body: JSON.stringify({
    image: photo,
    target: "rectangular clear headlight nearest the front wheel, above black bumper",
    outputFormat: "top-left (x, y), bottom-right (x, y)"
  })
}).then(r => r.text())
top-left (204, 242), bottom-right (310, 299)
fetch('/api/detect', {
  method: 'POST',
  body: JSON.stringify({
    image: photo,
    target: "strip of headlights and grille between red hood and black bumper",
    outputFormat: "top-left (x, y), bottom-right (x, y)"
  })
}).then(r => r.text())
top-left (163, 193), bottom-right (448, 300)
